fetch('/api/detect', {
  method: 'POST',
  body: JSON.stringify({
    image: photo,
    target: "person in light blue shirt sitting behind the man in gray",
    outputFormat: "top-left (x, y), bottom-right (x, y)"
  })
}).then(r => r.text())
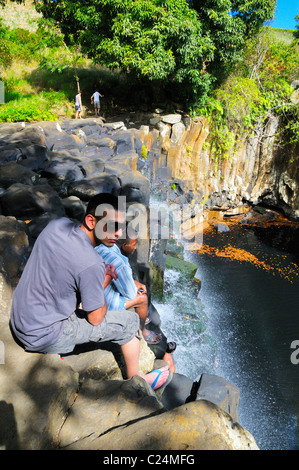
top-left (96, 234), bottom-right (162, 344)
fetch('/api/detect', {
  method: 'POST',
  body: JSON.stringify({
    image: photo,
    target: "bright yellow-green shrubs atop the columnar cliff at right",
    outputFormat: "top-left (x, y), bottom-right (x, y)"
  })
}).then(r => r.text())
top-left (192, 28), bottom-right (299, 161)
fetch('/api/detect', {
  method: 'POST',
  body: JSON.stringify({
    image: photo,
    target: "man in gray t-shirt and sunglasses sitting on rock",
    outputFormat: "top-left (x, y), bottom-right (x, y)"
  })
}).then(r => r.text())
top-left (11, 194), bottom-right (169, 390)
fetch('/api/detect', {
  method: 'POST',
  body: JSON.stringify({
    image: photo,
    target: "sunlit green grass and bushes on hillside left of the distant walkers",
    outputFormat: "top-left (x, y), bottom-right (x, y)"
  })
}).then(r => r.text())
top-left (0, 12), bottom-right (87, 122)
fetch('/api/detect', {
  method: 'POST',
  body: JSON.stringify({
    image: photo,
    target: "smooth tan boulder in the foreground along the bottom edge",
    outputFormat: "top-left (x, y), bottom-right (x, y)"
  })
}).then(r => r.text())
top-left (63, 400), bottom-right (258, 452)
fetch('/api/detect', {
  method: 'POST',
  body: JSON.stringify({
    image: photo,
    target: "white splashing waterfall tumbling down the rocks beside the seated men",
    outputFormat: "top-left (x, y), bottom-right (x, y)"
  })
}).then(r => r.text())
top-left (150, 198), bottom-right (217, 381)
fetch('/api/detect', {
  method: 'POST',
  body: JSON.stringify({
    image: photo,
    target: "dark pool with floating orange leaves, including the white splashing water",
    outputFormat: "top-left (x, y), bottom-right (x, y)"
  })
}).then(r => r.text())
top-left (155, 222), bottom-right (299, 450)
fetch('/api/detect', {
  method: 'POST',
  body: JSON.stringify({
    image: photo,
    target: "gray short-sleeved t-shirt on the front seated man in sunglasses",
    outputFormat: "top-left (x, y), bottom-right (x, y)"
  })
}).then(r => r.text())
top-left (11, 218), bottom-right (105, 351)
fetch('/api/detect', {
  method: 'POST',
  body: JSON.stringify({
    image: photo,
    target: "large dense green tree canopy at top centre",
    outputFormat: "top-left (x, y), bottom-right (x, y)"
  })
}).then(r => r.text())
top-left (32, 0), bottom-right (276, 101)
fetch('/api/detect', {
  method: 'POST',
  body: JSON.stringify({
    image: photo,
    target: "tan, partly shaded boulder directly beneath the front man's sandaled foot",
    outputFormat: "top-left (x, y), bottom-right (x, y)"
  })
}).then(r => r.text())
top-left (59, 376), bottom-right (163, 449)
